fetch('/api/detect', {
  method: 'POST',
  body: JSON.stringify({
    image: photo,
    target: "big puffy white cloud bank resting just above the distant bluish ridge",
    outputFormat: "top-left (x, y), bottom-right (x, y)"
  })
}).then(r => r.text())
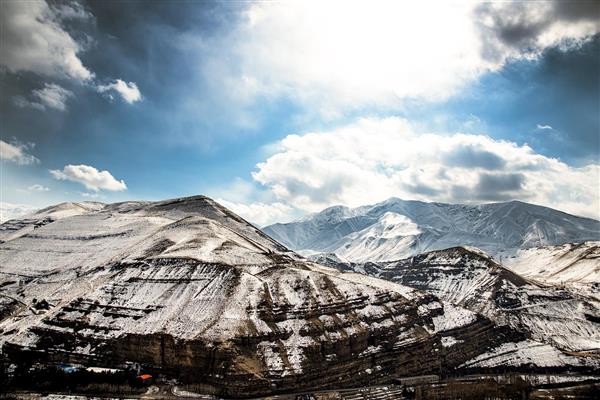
top-left (253, 118), bottom-right (600, 218)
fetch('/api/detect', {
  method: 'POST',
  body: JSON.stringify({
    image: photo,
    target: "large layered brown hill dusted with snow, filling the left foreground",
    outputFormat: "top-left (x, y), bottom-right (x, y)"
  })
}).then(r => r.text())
top-left (0, 196), bottom-right (564, 397)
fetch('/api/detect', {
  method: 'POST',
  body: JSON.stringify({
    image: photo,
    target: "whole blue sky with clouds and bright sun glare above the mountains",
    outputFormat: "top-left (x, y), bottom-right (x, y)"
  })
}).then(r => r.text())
top-left (0, 0), bottom-right (600, 226)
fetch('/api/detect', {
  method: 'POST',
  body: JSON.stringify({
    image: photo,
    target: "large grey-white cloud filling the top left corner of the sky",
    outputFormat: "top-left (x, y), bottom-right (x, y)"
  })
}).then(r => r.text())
top-left (0, 0), bottom-right (94, 82)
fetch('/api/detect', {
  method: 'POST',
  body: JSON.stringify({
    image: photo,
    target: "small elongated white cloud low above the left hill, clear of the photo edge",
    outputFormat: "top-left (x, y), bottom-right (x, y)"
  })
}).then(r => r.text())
top-left (50, 164), bottom-right (127, 192)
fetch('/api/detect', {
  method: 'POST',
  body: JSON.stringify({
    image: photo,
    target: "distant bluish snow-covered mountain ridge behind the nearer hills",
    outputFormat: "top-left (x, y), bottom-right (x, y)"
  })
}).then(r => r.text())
top-left (263, 198), bottom-right (600, 262)
